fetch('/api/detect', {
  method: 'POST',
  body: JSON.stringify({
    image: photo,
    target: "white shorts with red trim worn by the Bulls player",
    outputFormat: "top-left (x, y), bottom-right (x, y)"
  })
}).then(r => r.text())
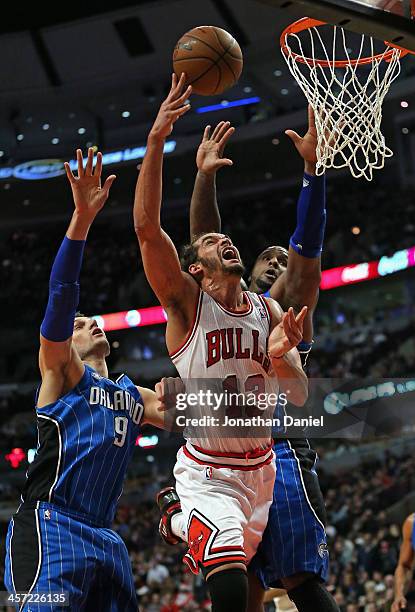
top-left (174, 442), bottom-right (275, 574)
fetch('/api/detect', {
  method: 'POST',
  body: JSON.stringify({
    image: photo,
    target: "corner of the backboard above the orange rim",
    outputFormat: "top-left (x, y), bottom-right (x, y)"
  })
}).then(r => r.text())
top-left (257, 0), bottom-right (415, 53)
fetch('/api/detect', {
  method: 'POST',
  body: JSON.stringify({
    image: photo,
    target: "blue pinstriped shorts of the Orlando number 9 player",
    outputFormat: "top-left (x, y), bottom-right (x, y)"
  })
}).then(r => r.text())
top-left (4, 502), bottom-right (138, 612)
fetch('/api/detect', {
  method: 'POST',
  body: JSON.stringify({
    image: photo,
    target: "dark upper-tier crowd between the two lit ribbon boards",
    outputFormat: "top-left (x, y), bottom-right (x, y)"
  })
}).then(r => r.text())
top-left (0, 182), bottom-right (415, 338)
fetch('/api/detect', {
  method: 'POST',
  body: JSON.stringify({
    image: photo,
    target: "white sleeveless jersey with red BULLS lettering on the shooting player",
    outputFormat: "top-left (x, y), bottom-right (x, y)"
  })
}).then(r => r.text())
top-left (170, 291), bottom-right (278, 453)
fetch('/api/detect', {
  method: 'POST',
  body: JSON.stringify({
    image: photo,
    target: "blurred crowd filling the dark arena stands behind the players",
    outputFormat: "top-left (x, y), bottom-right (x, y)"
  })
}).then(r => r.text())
top-left (0, 175), bottom-right (415, 612)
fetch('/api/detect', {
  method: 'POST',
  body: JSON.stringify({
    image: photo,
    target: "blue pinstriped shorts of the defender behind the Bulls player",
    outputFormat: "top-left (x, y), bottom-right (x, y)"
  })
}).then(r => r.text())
top-left (249, 440), bottom-right (329, 589)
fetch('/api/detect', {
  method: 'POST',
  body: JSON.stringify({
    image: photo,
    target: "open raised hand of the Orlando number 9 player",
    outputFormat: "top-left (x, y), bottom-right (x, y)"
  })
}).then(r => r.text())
top-left (64, 147), bottom-right (116, 219)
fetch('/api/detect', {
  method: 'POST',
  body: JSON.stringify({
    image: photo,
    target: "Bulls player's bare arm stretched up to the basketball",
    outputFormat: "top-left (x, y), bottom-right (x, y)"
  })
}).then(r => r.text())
top-left (134, 74), bottom-right (199, 351)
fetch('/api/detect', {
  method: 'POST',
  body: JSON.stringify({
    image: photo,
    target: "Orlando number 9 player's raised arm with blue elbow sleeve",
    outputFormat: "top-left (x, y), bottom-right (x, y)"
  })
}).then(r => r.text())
top-left (38, 148), bottom-right (116, 406)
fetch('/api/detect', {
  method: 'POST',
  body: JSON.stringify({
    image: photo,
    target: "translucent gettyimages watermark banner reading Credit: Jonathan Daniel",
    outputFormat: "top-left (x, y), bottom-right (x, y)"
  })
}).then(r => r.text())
top-left (160, 375), bottom-right (415, 440)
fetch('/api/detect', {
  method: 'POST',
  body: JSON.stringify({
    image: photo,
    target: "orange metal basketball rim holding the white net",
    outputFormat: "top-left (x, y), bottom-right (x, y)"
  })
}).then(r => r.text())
top-left (280, 17), bottom-right (412, 68)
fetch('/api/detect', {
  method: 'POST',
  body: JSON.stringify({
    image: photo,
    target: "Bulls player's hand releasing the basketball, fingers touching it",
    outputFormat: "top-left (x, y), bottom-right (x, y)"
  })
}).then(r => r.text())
top-left (149, 72), bottom-right (192, 140)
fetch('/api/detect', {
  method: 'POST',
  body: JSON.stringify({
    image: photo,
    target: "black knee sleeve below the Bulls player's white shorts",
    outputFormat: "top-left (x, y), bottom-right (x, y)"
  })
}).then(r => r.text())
top-left (206, 564), bottom-right (248, 612)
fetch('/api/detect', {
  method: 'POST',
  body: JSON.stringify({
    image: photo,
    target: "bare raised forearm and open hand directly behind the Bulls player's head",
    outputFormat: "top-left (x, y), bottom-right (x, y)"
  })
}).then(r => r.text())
top-left (190, 121), bottom-right (235, 240)
